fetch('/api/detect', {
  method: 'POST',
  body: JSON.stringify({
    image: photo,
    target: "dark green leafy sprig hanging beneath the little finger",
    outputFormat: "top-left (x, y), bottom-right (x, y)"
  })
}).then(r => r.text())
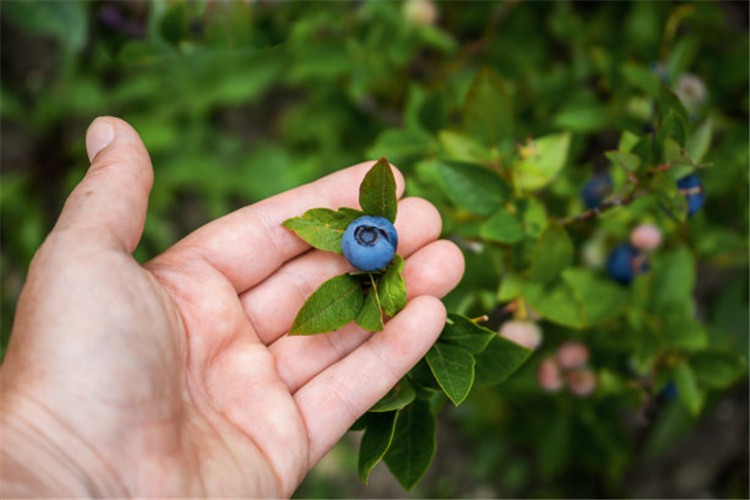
top-left (351, 314), bottom-right (531, 490)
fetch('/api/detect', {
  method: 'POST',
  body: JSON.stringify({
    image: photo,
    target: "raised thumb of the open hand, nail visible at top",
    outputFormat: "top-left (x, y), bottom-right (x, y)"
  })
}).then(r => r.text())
top-left (53, 116), bottom-right (154, 253)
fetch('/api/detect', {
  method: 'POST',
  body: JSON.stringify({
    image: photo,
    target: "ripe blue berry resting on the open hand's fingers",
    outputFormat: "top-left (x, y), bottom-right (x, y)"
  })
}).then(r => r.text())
top-left (341, 215), bottom-right (398, 272)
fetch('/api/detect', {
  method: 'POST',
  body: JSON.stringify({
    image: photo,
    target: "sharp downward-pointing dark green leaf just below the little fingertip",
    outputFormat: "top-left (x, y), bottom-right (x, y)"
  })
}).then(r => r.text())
top-left (425, 342), bottom-right (475, 406)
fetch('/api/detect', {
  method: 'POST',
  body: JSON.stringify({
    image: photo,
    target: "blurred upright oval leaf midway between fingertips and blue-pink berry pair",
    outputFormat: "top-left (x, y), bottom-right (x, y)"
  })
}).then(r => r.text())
top-left (530, 221), bottom-right (574, 283)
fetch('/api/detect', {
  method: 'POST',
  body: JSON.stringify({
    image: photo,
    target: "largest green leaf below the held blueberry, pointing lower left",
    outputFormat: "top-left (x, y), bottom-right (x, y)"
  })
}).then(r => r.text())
top-left (289, 274), bottom-right (365, 335)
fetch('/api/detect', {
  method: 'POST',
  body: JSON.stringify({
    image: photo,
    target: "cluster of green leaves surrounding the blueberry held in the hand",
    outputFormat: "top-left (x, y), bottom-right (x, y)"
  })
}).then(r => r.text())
top-left (283, 157), bottom-right (406, 335)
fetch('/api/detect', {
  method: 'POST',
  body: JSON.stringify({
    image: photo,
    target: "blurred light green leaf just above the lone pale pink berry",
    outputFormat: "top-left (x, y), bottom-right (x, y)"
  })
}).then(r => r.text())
top-left (523, 280), bottom-right (585, 329)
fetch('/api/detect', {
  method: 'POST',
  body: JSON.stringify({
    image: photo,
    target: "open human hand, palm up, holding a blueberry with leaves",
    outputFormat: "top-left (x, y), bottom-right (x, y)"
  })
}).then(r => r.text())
top-left (0, 117), bottom-right (463, 497)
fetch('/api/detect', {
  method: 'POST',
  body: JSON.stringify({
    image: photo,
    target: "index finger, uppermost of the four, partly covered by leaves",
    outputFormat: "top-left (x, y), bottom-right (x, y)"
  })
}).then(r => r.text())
top-left (154, 161), bottom-right (404, 293)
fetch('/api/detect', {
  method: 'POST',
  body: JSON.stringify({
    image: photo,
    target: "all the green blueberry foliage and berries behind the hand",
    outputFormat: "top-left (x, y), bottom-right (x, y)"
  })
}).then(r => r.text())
top-left (0, 0), bottom-right (750, 498)
